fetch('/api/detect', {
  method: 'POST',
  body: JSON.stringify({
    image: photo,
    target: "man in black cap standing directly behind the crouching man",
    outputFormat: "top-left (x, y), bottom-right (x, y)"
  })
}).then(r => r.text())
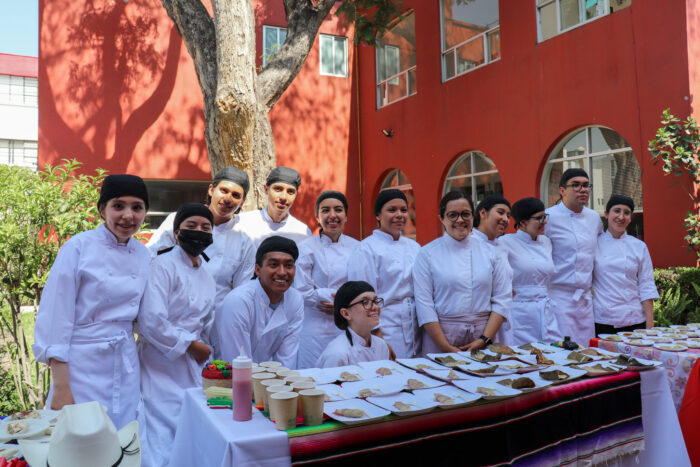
top-left (235, 166), bottom-right (311, 248)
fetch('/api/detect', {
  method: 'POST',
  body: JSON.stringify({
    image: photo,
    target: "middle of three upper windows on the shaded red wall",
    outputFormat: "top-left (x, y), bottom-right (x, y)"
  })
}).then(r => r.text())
top-left (440, 0), bottom-right (501, 81)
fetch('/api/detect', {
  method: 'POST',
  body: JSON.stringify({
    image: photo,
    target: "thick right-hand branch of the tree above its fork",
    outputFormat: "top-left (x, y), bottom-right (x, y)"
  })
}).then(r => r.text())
top-left (256, 0), bottom-right (336, 110)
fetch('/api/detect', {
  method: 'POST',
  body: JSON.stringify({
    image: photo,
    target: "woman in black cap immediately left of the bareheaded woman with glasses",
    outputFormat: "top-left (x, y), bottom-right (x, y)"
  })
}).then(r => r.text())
top-left (348, 189), bottom-right (421, 358)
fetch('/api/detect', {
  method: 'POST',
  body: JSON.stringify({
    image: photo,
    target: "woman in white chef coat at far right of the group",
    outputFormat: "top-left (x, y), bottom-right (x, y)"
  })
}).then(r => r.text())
top-left (593, 195), bottom-right (659, 335)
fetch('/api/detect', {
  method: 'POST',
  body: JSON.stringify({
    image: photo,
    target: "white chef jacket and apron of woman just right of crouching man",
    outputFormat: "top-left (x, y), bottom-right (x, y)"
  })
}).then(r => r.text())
top-left (294, 234), bottom-right (360, 368)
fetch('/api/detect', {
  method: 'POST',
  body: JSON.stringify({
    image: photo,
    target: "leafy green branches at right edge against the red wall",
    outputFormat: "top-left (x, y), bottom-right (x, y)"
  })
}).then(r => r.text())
top-left (649, 109), bottom-right (700, 259)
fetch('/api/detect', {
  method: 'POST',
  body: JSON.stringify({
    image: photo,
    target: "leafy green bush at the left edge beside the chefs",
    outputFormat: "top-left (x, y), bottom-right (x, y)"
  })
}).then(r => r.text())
top-left (0, 160), bottom-right (105, 408)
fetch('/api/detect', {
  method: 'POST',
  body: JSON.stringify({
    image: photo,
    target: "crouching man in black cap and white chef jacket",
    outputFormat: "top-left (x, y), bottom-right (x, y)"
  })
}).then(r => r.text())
top-left (213, 235), bottom-right (304, 368)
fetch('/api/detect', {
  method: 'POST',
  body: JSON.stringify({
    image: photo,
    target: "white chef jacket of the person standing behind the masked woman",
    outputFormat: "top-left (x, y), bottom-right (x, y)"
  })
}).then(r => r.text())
top-left (146, 212), bottom-right (255, 305)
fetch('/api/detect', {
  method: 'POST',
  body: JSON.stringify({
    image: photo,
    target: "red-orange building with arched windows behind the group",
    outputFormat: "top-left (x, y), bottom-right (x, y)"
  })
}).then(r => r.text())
top-left (39, 0), bottom-right (700, 266)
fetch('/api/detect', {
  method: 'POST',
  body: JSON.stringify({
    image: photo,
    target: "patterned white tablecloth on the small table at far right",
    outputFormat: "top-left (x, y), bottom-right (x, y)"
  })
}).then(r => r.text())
top-left (591, 339), bottom-right (700, 412)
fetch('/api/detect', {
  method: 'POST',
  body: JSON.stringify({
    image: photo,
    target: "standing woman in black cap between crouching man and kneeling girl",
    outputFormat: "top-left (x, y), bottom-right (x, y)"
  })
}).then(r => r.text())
top-left (294, 191), bottom-right (360, 368)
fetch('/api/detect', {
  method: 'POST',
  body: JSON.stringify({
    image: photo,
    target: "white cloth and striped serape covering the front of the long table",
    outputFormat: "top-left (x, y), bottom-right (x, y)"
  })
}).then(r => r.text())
top-left (170, 369), bottom-right (690, 466)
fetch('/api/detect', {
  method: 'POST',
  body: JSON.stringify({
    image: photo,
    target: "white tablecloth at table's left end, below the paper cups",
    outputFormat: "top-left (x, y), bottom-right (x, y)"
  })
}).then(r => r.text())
top-left (170, 388), bottom-right (291, 467)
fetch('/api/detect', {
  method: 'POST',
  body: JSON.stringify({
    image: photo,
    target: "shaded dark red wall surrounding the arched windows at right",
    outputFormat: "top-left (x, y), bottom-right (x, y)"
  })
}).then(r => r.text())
top-left (359, 0), bottom-right (694, 267)
